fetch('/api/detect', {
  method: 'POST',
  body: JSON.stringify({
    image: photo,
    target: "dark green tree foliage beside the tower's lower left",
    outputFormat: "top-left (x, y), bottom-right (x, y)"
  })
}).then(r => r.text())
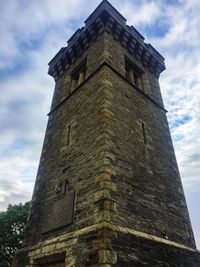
top-left (0, 202), bottom-right (30, 267)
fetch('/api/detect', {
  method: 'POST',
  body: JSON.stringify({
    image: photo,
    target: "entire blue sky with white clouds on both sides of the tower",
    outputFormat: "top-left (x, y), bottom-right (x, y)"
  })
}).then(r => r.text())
top-left (0, 0), bottom-right (200, 248)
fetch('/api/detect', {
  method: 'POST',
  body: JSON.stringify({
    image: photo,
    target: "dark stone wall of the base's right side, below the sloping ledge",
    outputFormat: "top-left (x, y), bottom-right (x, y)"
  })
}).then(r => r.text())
top-left (112, 229), bottom-right (200, 267)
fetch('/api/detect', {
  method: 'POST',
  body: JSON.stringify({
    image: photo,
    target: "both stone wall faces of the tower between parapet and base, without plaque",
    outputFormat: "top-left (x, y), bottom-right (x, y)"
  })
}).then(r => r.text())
top-left (23, 30), bottom-right (194, 250)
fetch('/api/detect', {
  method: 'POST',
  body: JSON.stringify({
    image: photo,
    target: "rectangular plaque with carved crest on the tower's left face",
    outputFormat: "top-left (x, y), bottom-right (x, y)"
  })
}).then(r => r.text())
top-left (42, 186), bottom-right (75, 233)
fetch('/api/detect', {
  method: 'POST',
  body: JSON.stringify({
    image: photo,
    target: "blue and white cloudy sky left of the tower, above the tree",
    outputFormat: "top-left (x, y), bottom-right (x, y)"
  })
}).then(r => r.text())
top-left (0, 0), bottom-right (101, 210)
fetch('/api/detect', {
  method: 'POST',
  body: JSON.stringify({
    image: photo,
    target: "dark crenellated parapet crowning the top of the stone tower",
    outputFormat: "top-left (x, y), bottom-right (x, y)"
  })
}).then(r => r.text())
top-left (48, 0), bottom-right (165, 80)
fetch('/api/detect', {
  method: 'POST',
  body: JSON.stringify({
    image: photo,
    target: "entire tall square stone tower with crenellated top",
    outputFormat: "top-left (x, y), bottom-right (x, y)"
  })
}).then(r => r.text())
top-left (13, 0), bottom-right (200, 267)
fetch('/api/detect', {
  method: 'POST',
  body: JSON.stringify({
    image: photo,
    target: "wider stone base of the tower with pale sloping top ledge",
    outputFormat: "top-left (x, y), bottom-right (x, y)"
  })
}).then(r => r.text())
top-left (12, 223), bottom-right (200, 267)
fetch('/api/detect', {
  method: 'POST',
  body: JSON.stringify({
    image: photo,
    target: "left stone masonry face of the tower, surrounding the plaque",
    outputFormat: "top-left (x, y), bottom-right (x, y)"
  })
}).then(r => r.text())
top-left (24, 35), bottom-right (116, 246)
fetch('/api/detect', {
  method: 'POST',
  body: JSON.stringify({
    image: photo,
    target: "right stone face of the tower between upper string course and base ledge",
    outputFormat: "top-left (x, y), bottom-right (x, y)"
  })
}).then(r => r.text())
top-left (102, 61), bottom-right (194, 246)
